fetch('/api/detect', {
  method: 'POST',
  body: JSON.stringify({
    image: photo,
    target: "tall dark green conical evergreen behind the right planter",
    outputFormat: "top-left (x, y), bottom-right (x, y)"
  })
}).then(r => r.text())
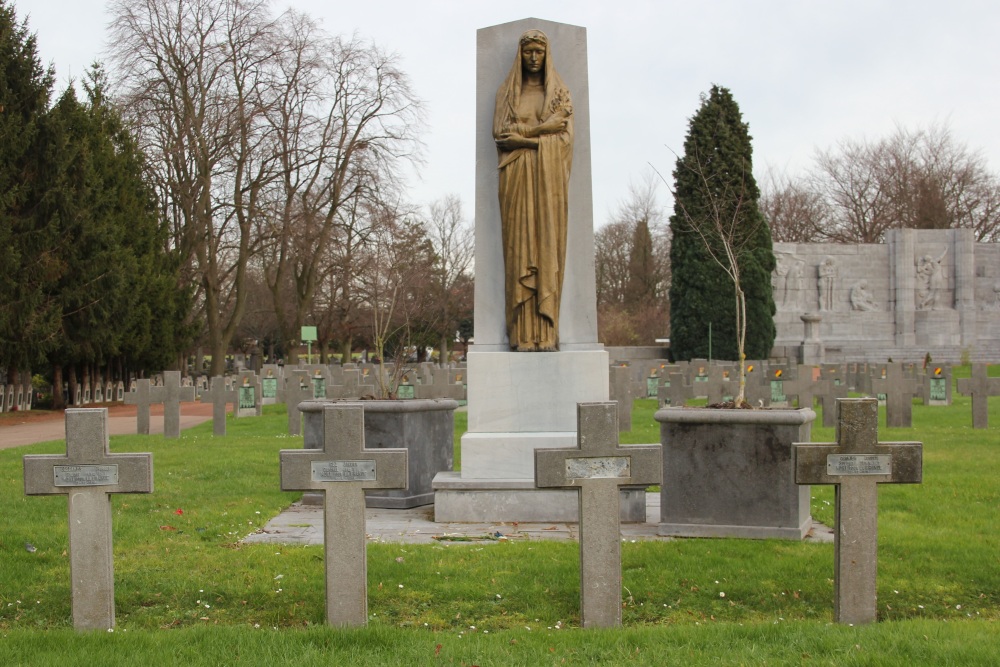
top-left (670, 86), bottom-right (775, 360)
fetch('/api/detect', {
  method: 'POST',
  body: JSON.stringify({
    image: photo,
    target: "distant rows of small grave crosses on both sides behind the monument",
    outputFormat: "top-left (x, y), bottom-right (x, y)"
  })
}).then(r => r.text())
top-left (0, 358), bottom-right (1000, 431)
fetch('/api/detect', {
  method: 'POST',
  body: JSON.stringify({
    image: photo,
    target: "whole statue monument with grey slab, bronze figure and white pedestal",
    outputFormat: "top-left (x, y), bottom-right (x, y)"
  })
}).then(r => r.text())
top-left (434, 19), bottom-right (624, 522)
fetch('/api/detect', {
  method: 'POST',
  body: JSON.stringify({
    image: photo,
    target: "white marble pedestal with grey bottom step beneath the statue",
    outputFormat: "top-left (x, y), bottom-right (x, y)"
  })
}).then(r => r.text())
top-left (433, 348), bottom-right (646, 523)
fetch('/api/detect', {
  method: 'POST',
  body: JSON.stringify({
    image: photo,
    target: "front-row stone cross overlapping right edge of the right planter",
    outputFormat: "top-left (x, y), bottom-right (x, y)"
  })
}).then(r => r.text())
top-left (793, 398), bottom-right (923, 624)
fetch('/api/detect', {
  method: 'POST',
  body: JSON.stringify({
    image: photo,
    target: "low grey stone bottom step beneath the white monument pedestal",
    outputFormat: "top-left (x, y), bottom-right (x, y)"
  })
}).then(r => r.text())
top-left (433, 472), bottom-right (646, 523)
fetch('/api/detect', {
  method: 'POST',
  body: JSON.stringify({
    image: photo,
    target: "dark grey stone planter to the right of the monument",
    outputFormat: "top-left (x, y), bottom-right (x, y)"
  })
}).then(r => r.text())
top-left (655, 408), bottom-right (816, 540)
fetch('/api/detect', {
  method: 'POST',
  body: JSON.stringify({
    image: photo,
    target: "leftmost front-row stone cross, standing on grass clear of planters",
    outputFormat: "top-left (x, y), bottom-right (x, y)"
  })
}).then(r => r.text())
top-left (24, 408), bottom-right (153, 630)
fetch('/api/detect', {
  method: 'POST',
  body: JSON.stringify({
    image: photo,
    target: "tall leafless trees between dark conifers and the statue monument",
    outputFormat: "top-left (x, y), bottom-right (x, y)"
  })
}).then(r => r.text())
top-left (110, 0), bottom-right (471, 374)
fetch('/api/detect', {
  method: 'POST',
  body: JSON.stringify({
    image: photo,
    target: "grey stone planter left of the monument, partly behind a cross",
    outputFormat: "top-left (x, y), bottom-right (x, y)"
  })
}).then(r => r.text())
top-left (299, 399), bottom-right (458, 509)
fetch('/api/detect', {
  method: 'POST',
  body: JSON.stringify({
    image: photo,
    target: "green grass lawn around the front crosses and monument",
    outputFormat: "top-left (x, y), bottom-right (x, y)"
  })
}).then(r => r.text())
top-left (0, 374), bottom-right (1000, 666)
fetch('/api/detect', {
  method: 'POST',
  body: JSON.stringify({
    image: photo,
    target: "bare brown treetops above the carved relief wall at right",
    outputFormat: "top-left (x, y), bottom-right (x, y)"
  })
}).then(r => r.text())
top-left (761, 125), bottom-right (1000, 243)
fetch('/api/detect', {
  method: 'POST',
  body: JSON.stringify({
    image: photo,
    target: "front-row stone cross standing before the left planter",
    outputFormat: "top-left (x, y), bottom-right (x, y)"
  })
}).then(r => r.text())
top-left (280, 404), bottom-right (406, 625)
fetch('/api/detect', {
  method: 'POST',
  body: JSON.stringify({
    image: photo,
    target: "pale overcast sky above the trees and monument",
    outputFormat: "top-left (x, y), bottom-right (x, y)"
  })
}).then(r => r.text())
top-left (13, 0), bottom-right (1000, 226)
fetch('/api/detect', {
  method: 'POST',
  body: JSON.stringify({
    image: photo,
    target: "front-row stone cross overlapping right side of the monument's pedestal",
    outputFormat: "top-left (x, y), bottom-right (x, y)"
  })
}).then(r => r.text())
top-left (535, 401), bottom-right (663, 628)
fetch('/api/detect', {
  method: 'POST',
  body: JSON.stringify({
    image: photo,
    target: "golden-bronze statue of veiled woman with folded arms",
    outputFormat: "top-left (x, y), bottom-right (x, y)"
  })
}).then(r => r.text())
top-left (493, 30), bottom-right (573, 352)
